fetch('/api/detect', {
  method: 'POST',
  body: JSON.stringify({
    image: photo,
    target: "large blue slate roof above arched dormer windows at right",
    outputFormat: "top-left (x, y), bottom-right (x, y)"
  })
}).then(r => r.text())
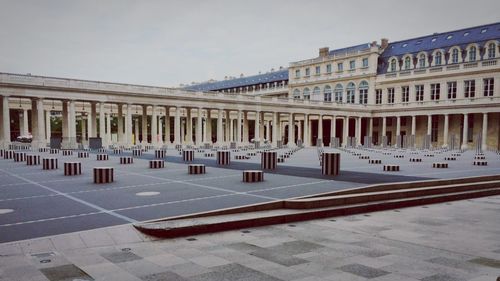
top-left (381, 22), bottom-right (500, 58)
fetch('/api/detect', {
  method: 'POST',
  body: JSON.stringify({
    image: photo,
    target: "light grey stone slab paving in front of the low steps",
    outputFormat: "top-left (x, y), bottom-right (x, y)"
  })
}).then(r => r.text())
top-left (0, 196), bottom-right (500, 281)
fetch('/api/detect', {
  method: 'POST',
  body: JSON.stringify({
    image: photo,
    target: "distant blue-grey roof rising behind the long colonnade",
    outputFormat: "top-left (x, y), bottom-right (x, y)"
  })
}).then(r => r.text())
top-left (184, 69), bottom-right (288, 91)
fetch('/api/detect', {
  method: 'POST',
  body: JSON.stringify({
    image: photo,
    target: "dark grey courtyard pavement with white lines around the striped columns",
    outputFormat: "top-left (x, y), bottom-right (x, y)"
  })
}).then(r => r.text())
top-left (0, 145), bottom-right (500, 242)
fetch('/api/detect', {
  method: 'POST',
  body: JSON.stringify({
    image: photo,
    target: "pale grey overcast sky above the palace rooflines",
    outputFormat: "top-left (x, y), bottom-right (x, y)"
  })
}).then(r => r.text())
top-left (0, 0), bottom-right (500, 87)
